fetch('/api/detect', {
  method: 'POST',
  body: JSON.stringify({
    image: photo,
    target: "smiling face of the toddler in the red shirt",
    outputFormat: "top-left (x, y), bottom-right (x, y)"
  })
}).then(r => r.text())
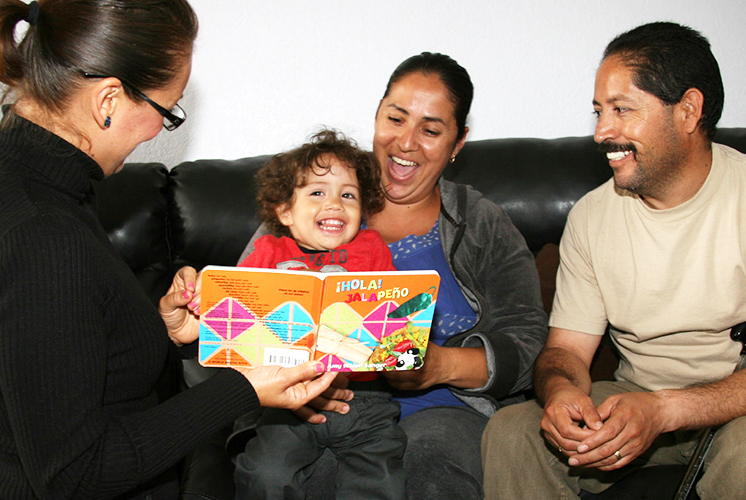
top-left (277, 156), bottom-right (362, 250)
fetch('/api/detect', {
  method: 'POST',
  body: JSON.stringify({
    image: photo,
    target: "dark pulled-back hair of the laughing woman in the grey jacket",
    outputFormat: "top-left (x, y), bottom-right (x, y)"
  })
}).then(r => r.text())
top-left (383, 52), bottom-right (474, 141)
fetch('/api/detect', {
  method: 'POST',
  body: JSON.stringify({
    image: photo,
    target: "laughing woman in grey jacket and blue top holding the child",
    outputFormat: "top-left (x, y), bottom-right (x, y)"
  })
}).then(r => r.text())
top-left (236, 53), bottom-right (547, 500)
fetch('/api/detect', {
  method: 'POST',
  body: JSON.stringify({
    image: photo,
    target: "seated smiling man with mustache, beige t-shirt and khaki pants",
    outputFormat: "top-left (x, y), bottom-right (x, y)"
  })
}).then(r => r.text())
top-left (482, 23), bottom-right (746, 500)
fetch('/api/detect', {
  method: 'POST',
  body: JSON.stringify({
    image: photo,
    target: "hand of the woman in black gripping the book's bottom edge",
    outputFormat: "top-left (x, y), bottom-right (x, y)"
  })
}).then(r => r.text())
top-left (233, 361), bottom-right (337, 410)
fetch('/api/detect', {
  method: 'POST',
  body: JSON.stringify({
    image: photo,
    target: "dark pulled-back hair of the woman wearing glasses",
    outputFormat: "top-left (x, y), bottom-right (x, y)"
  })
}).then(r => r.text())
top-left (0, 0), bottom-right (198, 122)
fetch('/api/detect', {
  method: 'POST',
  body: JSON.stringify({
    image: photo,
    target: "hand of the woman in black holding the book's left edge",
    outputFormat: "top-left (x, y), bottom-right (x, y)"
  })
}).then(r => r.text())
top-left (158, 266), bottom-right (202, 346)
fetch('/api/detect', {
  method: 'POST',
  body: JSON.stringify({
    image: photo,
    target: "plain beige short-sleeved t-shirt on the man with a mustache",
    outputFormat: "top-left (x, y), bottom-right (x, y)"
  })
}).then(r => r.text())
top-left (549, 144), bottom-right (746, 390)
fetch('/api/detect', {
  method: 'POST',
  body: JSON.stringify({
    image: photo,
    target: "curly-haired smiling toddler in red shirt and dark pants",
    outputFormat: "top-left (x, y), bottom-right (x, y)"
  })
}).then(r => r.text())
top-left (235, 130), bottom-right (406, 500)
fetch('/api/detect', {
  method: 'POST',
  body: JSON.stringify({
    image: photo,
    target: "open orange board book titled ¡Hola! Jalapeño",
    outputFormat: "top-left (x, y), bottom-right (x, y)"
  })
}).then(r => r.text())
top-left (199, 266), bottom-right (440, 371)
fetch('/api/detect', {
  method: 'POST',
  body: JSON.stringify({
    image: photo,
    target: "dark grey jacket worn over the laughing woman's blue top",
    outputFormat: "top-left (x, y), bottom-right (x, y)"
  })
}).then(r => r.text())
top-left (439, 179), bottom-right (547, 416)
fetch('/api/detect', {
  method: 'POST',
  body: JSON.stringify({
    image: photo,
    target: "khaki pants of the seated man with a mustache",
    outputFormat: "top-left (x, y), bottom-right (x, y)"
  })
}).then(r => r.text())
top-left (482, 382), bottom-right (746, 500)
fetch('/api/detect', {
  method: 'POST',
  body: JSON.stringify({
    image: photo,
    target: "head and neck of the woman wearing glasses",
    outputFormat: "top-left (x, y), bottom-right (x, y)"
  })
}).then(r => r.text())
top-left (3, 0), bottom-right (197, 175)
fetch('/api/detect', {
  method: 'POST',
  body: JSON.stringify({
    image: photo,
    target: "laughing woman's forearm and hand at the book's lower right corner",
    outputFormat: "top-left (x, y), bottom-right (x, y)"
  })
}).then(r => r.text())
top-left (381, 343), bottom-right (487, 391)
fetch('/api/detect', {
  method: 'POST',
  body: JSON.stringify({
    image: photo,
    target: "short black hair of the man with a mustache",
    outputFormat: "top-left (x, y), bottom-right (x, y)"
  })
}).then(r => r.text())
top-left (604, 22), bottom-right (725, 140)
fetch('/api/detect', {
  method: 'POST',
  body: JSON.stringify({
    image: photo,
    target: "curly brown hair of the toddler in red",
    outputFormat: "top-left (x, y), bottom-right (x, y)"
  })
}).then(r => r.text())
top-left (256, 128), bottom-right (384, 236)
